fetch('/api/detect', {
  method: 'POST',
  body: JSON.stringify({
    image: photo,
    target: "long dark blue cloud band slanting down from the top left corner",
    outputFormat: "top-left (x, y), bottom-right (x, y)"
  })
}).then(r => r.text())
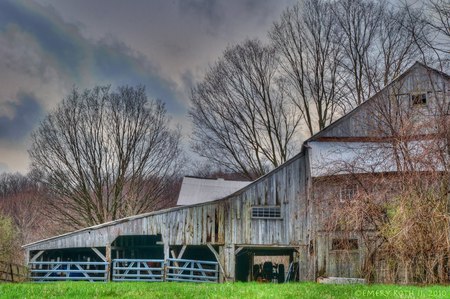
top-left (0, 1), bottom-right (181, 114)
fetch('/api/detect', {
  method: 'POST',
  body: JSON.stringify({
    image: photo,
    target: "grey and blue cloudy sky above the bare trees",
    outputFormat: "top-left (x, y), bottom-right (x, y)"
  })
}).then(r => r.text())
top-left (0, 0), bottom-right (294, 173)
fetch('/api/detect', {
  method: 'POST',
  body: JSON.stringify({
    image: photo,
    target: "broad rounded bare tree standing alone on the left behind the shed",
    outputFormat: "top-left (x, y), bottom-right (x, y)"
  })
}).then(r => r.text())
top-left (29, 87), bottom-right (180, 227)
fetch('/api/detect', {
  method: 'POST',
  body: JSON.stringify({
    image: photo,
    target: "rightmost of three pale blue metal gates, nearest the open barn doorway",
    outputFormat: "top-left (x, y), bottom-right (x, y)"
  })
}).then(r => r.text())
top-left (166, 259), bottom-right (219, 282)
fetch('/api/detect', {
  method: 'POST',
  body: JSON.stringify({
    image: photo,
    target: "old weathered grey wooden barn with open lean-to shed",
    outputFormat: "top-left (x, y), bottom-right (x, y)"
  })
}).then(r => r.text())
top-left (24, 63), bottom-right (450, 282)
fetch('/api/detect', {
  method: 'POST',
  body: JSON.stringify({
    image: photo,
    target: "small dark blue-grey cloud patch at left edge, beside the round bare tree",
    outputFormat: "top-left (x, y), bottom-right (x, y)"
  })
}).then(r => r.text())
top-left (0, 92), bottom-right (44, 141)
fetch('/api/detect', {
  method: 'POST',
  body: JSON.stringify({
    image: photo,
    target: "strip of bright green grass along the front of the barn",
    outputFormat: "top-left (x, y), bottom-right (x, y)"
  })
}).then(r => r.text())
top-left (0, 282), bottom-right (450, 299)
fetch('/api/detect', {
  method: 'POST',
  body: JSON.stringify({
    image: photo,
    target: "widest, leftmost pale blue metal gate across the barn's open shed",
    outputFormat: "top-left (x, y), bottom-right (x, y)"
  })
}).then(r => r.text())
top-left (29, 261), bottom-right (108, 282)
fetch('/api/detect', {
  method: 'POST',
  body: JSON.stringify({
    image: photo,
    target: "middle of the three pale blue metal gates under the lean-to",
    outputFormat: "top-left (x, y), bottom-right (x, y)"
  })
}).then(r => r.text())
top-left (112, 259), bottom-right (164, 281)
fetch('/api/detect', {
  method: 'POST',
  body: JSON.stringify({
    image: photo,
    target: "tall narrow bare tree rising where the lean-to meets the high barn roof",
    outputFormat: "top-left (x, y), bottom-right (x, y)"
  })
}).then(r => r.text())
top-left (270, 0), bottom-right (343, 135)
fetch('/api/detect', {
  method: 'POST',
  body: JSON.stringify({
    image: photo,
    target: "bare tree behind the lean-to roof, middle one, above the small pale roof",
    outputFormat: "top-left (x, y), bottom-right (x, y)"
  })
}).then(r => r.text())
top-left (189, 40), bottom-right (301, 179)
